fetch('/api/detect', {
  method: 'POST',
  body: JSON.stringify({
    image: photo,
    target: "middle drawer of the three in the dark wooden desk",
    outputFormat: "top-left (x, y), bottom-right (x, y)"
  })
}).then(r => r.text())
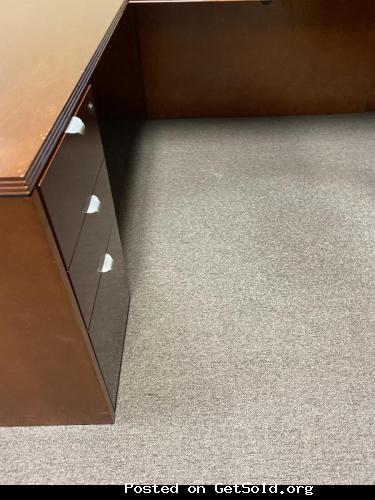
top-left (68, 161), bottom-right (115, 327)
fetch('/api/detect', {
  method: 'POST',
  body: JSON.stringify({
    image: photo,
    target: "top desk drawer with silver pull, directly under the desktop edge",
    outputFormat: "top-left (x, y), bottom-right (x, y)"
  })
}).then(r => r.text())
top-left (39, 84), bottom-right (104, 268)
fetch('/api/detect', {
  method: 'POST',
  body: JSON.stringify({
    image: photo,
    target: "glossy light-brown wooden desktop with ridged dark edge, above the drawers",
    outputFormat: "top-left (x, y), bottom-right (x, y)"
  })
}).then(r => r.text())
top-left (0, 0), bottom-right (127, 196)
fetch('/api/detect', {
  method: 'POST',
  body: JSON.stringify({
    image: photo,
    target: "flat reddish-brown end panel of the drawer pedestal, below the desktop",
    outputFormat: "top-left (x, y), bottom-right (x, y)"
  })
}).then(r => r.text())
top-left (0, 192), bottom-right (114, 426)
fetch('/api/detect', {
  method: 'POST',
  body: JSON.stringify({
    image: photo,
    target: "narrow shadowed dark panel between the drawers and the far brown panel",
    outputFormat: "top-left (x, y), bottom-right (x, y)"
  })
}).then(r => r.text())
top-left (92, 5), bottom-right (146, 118)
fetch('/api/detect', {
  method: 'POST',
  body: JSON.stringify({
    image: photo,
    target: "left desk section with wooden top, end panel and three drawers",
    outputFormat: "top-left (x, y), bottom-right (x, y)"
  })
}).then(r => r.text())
top-left (0, 0), bottom-right (128, 425)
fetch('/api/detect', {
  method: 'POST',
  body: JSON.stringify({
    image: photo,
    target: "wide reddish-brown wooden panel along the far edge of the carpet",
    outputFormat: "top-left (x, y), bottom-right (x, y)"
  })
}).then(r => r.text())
top-left (136, 0), bottom-right (375, 118)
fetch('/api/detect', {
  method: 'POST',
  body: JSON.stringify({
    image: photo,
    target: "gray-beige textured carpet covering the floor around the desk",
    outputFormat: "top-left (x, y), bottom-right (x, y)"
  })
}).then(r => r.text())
top-left (0, 114), bottom-right (375, 484)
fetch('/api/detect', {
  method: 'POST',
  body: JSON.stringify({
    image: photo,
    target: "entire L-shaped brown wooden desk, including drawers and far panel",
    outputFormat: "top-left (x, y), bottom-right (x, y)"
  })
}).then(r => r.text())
top-left (0, 0), bottom-right (375, 425)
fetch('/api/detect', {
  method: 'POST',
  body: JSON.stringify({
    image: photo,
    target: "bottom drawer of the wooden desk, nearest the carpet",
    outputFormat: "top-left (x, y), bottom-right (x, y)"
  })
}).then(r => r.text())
top-left (89, 221), bottom-right (129, 407)
